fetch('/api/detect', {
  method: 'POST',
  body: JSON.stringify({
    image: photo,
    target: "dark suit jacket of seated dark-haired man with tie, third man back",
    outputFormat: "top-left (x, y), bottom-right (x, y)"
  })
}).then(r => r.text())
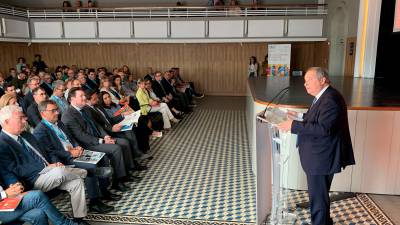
top-left (61, 106), bottom-right (107, 148)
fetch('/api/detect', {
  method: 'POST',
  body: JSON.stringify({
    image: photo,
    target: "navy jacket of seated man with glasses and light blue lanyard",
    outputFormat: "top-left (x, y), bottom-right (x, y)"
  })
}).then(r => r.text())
top-left (33, 121), bottom-right (78, 165)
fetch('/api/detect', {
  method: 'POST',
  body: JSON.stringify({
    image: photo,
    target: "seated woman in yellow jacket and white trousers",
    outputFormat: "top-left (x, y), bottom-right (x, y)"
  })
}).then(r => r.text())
top-left (136, 79), bottom-right (179, 129)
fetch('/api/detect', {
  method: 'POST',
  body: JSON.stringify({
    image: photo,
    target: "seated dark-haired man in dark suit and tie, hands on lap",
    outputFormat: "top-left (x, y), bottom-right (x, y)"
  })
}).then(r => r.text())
top-left (61, 87), bottom-right (127, 191)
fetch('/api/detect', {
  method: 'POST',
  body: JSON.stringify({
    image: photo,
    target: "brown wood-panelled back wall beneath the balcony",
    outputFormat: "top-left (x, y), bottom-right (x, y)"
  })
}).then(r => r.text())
top-left (0, 42), bottom-right (321, 95)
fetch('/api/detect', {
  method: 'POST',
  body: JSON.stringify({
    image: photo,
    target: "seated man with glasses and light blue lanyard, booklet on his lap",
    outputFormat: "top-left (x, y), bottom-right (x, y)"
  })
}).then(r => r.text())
top-left (33, 100), bottom-right (114, 213)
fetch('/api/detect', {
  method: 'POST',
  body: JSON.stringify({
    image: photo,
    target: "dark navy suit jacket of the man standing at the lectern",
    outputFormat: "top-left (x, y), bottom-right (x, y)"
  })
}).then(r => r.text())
top-left (291, 87), bottom-right (355, 175)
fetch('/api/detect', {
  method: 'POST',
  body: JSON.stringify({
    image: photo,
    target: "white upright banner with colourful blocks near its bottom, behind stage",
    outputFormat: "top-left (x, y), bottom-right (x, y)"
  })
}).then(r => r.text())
top-left (267, 44), bottom-right (291, 76)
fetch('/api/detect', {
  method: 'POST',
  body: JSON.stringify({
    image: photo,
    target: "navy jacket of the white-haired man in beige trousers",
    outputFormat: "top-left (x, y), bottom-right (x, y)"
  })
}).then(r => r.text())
top-left (0, 132), bottom-right (58, 189)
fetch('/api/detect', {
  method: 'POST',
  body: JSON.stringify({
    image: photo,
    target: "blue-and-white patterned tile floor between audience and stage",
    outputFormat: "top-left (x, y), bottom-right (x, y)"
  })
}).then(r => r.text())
top-left (54, 97), bottom-right (393, 225)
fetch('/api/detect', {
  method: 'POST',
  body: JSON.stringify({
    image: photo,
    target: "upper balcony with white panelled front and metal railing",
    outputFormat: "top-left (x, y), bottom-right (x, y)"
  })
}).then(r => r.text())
top-left (0, 4), bottom-right (327, 43)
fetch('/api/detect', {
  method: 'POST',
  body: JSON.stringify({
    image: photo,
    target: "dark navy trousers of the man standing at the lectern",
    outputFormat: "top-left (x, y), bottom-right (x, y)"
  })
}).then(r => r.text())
top-left (307, 174), bottom-right (334, 225)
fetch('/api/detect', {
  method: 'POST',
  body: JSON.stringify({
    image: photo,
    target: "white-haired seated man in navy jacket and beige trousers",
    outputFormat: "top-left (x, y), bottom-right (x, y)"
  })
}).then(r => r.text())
top-left (0, 105), bottom-right (87, 221)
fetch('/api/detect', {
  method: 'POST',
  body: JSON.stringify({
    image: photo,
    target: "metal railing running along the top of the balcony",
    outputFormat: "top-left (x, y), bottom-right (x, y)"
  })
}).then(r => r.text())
top-left (0, 4), bottom-right (327, 18)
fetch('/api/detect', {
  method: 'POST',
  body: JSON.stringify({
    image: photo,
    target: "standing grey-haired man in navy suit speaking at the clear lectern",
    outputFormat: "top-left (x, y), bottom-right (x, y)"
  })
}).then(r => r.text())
top-left (278, 67), bottom-right (355, 225)
